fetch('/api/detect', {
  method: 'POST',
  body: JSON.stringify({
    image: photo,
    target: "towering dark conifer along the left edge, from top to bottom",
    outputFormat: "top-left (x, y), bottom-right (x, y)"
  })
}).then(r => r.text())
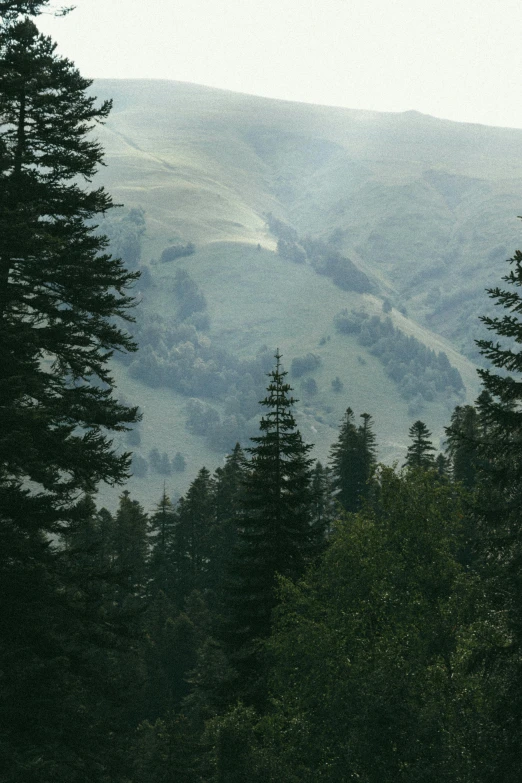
top-left (0, 9), bottom-right (138, 783)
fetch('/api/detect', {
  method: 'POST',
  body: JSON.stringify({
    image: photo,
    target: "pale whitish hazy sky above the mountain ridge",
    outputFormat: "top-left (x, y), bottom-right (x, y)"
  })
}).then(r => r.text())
top-left (39, 0), bottom-right (522, 128)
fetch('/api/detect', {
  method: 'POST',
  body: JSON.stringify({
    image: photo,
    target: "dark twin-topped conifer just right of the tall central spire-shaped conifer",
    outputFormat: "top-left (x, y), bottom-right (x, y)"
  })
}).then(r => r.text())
top-left (330, 408), bottom-right (376, 512)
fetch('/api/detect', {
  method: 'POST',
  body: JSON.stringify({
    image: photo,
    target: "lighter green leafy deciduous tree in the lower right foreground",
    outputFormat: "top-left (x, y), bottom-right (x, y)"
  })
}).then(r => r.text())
top-left (262, 469), bottom-right (490, 783)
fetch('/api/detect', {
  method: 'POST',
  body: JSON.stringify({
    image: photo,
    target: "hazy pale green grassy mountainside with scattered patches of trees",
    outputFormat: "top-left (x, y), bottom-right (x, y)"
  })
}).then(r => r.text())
top-left (90, 80), bottom-right (522, 502)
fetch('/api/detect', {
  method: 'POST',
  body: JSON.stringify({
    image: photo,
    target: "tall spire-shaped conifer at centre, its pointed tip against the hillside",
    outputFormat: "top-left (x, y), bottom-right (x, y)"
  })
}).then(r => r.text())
top-left (223, 352), bottom-right (320, 699)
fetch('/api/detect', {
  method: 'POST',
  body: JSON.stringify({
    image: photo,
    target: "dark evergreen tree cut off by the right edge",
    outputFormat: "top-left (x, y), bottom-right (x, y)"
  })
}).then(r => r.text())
top-left (468, 250), bottom-right (522, 781)
